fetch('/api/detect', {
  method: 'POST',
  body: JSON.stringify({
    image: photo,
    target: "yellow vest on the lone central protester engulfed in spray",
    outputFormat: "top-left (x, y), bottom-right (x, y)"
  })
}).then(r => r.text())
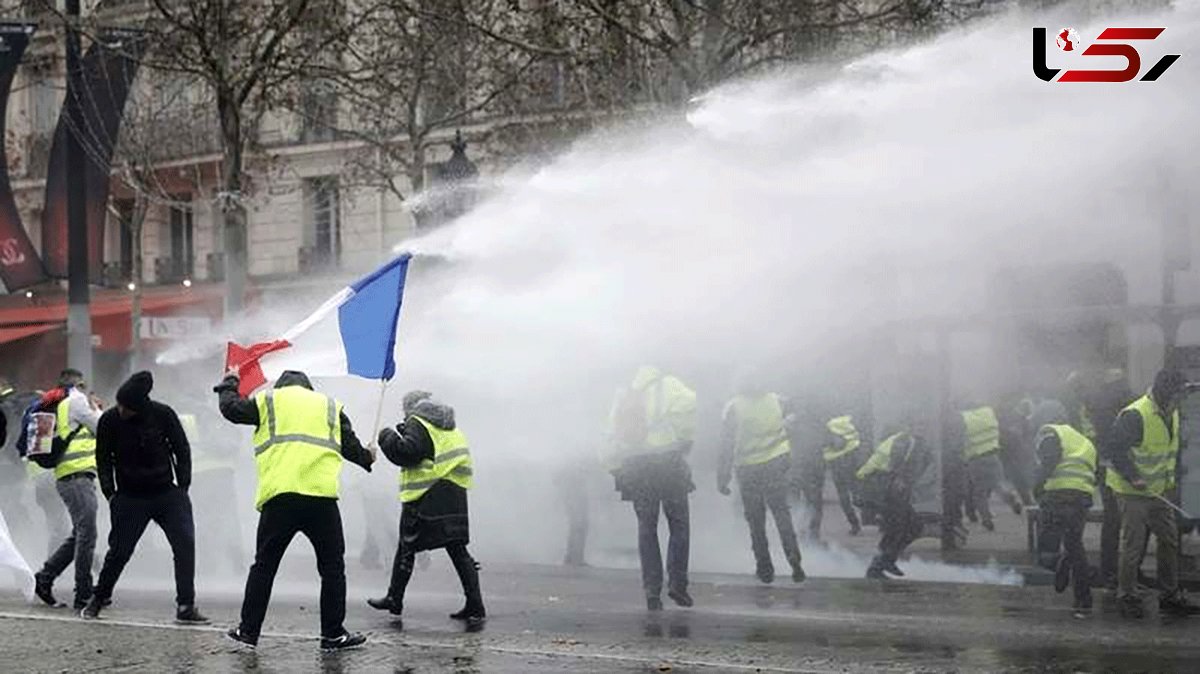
top-left (607, 367), bottom-right (696, 465)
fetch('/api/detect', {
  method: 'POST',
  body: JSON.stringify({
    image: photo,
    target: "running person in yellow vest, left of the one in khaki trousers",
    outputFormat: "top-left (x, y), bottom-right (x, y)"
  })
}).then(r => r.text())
top-left (1030, 401), bottom-right (1099, 618)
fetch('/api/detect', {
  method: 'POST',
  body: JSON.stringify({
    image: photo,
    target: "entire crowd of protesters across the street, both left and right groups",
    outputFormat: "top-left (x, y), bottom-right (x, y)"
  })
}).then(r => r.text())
top-left (0, 357), bottom-right (1200, 650)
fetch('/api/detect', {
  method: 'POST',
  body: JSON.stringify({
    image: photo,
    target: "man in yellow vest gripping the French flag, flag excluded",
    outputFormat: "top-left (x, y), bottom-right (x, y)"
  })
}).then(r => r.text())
top-left (214, 369), bottom-right (374, 651)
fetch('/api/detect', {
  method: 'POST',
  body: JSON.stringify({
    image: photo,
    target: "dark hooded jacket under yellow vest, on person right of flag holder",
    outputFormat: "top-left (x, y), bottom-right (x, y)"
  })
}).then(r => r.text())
top-left (379, 399), bottom-right (470, 552)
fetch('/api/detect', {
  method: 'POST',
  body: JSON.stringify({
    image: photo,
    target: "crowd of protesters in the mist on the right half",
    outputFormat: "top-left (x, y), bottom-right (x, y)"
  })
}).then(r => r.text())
top-left (600, 367), bottom-right (1200, 618)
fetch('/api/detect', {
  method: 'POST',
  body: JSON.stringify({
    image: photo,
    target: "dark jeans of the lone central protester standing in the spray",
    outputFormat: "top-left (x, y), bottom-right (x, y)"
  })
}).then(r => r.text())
top-left (634, 494), bottom-right (690, 597)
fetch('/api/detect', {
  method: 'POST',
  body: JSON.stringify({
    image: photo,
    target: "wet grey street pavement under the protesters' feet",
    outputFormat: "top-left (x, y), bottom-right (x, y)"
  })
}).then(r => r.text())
top-left (0, 559), bottom-right (1200, 673)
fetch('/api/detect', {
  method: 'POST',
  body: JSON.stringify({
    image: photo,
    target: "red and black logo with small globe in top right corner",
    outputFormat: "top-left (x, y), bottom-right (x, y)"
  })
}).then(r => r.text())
top-left (1033, 28), bottom-right (1180, 82)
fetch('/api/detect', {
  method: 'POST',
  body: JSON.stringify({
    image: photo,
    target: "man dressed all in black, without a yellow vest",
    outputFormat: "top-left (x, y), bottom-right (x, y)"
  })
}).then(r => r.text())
top-left (80, 372), bottom-right (209, 625)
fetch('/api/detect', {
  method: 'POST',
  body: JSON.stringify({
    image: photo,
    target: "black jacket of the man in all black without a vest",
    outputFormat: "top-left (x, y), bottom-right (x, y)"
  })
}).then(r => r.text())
top-left (96, 401), bottom-right (192, 498)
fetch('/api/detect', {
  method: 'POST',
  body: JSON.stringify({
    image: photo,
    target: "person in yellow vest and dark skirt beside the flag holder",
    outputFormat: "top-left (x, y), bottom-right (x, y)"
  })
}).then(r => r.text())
top-left (367, 391), bottom-right (487, 627)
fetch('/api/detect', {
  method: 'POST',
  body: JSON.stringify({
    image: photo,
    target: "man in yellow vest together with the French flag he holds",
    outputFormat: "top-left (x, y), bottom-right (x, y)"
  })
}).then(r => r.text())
top-left (214, 253), bottom-right (410, 650)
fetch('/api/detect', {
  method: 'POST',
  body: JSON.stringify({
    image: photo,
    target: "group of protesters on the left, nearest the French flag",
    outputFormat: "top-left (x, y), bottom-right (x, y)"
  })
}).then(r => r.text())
top-left (0, 369), bottom-right (486, 651)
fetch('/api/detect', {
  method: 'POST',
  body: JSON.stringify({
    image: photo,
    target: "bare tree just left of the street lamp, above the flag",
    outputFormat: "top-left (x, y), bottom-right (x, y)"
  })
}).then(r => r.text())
top-left (304, 0), bottom-right (551, 200)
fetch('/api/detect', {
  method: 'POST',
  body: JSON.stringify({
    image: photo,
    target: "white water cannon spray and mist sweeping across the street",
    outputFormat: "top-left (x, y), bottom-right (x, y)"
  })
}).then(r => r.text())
top-left (2, 2), bottom-right (1200, 590)
